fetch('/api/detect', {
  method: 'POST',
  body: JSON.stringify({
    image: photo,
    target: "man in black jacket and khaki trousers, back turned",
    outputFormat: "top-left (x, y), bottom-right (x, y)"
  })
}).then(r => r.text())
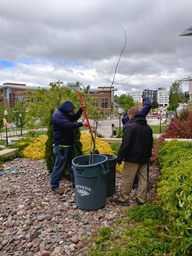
top-left (114, 107), bottom-right (153, 205)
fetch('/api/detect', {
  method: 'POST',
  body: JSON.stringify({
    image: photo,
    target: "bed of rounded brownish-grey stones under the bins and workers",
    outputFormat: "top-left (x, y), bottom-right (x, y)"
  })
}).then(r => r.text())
top-left (0, 158), bottom-right (159, 256)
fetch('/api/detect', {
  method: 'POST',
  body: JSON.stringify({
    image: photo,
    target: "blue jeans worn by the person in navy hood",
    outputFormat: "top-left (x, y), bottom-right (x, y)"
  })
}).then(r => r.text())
top-left (50, 145), bottom-right (76, 189)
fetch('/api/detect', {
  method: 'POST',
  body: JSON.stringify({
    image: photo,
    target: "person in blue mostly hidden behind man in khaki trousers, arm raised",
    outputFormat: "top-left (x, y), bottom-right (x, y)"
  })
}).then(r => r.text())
top-left (122, 92), bottom-right (152, 189)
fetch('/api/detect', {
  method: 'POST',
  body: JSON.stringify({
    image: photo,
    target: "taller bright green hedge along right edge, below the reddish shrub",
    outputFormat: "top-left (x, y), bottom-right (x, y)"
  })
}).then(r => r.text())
top-left (157, 140), bottom-right (192, 256)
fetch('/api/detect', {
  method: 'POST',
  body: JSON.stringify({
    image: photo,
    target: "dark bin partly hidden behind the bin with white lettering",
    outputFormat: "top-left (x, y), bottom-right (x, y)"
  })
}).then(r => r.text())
top-left (104, 154), bottom-right (117, 197)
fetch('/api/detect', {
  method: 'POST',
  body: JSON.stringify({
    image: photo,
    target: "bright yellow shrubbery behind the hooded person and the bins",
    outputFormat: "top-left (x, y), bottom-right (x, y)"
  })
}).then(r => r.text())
top-left (22, 132), bottom-right (122, 173)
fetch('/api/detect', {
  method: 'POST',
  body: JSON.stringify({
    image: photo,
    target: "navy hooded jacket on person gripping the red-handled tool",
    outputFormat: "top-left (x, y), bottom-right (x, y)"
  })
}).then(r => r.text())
top-left (52, 101), bottom-right (83, 145)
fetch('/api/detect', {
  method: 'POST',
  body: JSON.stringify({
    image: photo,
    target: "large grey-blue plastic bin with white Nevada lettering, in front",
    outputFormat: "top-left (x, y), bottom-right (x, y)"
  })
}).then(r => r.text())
top-left (72, 154), bottom-right (109, 210)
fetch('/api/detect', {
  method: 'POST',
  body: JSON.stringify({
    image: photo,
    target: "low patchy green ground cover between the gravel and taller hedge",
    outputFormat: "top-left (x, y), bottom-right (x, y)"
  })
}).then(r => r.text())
top-left (88, 204), bottom-right (170, 256)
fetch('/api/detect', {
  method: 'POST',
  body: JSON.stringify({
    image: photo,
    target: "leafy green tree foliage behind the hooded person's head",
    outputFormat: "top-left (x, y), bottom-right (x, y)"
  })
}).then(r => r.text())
top-left (26, 81), bottom-right (99, 132)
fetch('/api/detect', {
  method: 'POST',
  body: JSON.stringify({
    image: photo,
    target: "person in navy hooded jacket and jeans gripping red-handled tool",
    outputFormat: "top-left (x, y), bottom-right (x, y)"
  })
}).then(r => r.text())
top-left (50, 101), bottom-right (88, 195)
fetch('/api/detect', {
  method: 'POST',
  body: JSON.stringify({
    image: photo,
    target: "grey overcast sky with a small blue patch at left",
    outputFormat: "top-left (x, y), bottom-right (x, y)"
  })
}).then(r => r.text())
top-left (0, 0), bottom-right (192, 95)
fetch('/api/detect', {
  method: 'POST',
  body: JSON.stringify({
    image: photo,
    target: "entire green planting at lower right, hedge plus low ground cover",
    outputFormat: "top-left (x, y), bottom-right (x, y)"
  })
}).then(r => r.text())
top-left (88, 140), bottom-right (192, 256)
